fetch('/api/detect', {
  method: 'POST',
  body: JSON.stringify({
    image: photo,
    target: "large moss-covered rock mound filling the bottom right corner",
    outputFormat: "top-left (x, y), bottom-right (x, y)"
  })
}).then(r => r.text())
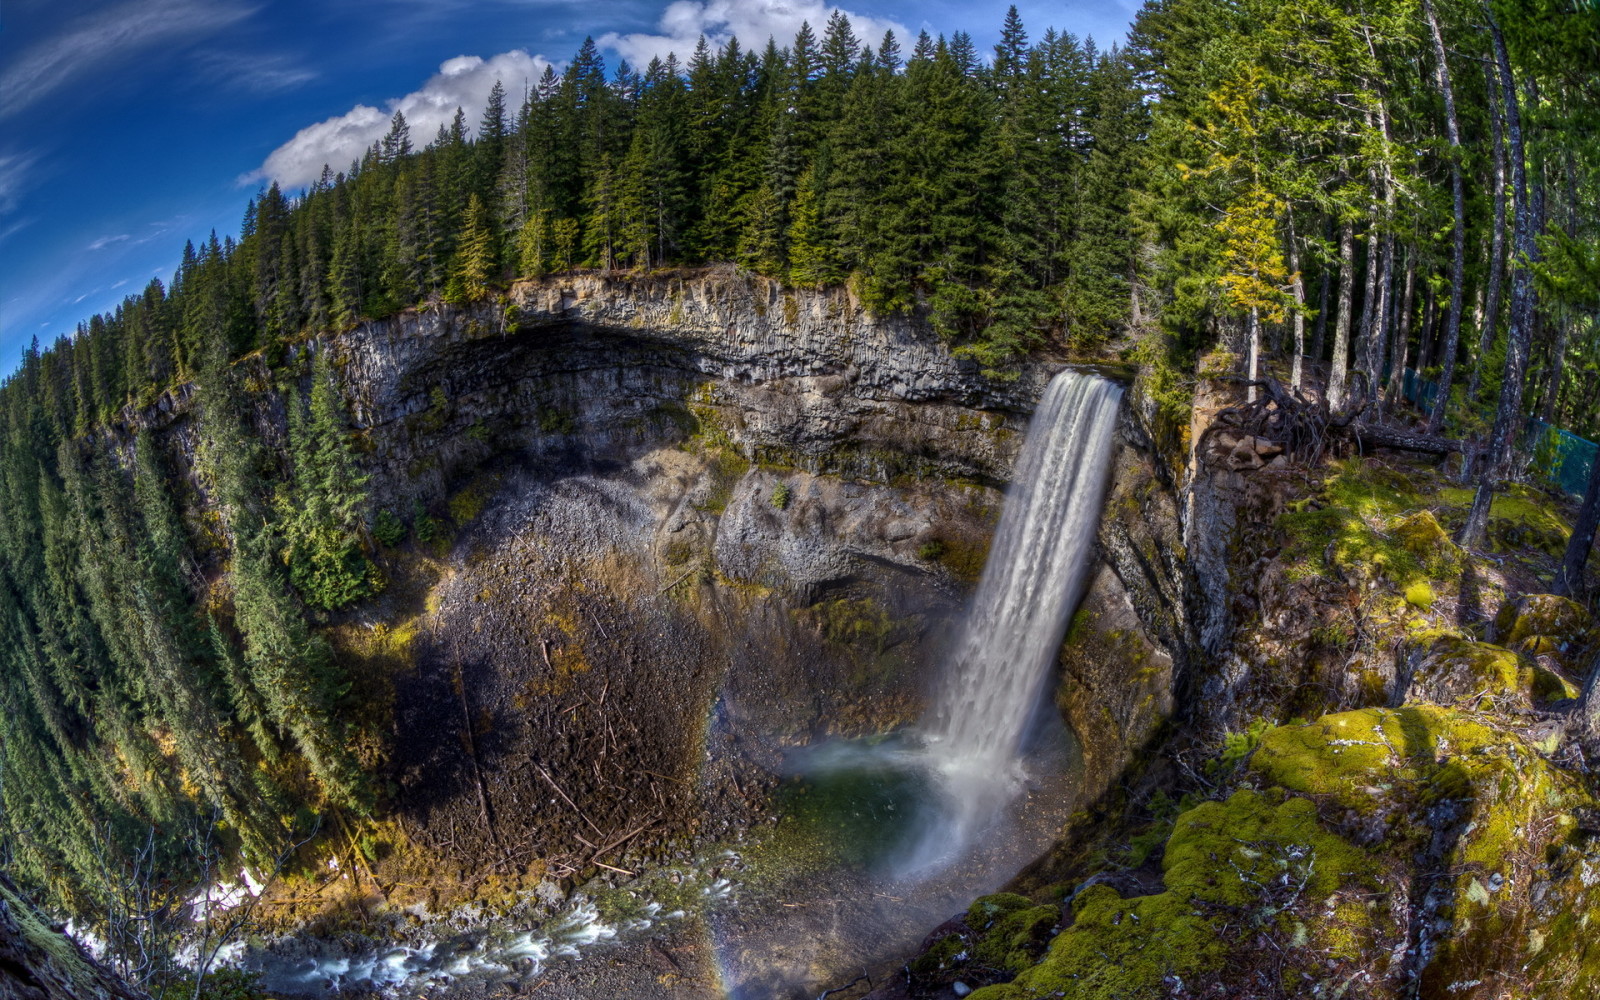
top-left (973, 706), bottom-right (1600, 1000)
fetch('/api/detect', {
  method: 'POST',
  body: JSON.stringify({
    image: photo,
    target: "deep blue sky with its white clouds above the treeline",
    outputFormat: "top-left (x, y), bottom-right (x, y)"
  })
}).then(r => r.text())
top-left (0, 0), bottom-right (1138, 373)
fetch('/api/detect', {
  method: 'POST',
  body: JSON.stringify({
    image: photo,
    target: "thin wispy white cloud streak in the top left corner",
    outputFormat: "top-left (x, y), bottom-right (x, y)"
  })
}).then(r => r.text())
top-left (0, 0), bottom-right (254, 118)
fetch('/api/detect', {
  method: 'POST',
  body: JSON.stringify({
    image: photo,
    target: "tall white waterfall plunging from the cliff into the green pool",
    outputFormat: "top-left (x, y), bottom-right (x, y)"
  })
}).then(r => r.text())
top-left (923, 371), bottom-right (1122, 819)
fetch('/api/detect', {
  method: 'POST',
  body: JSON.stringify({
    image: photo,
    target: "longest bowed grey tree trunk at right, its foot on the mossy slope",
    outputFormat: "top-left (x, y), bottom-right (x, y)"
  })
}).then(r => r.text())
top-left (1461, 3), bottom-right (1539, 547)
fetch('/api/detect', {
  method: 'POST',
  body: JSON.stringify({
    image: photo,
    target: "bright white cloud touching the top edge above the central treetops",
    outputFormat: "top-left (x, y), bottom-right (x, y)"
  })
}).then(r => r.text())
top-left (598, 0), bottom-right (909, 67)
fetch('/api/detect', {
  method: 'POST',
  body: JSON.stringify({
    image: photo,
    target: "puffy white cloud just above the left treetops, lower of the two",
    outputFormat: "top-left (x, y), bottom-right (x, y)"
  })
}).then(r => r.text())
top-left (240, 48), bottom-right (550, 187)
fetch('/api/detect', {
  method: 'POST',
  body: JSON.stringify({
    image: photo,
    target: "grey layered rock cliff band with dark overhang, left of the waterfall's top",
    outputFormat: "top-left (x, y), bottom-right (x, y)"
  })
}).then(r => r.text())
top-left (330, 272), bottom-right (1048, 505)
